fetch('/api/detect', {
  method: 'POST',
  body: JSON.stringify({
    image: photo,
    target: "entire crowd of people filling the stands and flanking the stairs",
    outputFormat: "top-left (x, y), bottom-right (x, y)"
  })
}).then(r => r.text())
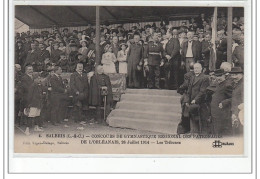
top-left (15, 13), bottom-right (244, 134)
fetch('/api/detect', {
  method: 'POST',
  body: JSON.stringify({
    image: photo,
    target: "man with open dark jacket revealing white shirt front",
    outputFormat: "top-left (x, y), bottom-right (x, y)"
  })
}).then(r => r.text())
top-left (182, 31), bottom-right (201, 72)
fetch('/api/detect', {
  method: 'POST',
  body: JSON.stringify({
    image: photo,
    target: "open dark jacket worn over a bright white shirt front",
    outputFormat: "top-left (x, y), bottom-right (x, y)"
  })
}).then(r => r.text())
top-left (181, 40), bottom-right (201, 62)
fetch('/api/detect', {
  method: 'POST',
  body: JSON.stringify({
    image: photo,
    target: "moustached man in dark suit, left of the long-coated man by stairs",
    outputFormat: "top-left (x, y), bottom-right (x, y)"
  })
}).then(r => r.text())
top-left (70, 63), bottom-right (89, 122)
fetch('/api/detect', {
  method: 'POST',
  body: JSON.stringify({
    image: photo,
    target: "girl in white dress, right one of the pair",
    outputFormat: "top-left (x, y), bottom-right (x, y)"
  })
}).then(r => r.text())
top-left (117, 43), bottom-right (127, 74)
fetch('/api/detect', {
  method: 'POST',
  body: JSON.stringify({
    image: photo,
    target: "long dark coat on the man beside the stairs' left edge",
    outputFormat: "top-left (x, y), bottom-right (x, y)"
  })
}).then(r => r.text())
top-left (89, 74), bottom-right (113, 106)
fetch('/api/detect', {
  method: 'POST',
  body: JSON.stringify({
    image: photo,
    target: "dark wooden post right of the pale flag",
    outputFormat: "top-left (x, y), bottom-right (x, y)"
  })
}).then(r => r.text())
top-left (227, 7), bottom-right (233, 63)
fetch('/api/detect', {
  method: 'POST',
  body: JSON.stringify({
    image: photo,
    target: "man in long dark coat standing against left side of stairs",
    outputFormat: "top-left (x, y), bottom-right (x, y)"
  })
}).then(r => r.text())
top-left (89, 65), bottom-right (113, 123)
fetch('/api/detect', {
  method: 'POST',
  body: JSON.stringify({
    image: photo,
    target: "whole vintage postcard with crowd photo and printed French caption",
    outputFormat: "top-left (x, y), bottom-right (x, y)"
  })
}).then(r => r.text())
top-left (9, 1), bottom-right (252, 157)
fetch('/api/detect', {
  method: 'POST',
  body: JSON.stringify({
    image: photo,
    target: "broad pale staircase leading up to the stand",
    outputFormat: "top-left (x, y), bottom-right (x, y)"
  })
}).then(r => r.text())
top-left (107, 89), bottom-right (181, 134)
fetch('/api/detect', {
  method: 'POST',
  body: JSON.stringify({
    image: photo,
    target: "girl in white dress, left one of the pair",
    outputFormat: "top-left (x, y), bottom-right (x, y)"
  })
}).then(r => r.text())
top-left (101, 44), bottom-right (117, 74)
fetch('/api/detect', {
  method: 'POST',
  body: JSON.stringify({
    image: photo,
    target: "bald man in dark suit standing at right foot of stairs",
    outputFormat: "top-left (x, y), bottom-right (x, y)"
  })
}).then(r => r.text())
top-left (184, 63), bottom-right (209, 133)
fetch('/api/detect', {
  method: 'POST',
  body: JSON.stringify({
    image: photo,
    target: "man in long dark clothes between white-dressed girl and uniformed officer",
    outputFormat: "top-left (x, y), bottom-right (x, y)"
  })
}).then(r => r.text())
top-left (127, 33), bottom-right (143, 88)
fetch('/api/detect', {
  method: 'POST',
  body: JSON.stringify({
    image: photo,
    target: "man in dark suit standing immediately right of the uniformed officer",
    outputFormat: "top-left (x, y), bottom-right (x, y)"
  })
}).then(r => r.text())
top-left (164, 32), bottom-right (181, 89)
